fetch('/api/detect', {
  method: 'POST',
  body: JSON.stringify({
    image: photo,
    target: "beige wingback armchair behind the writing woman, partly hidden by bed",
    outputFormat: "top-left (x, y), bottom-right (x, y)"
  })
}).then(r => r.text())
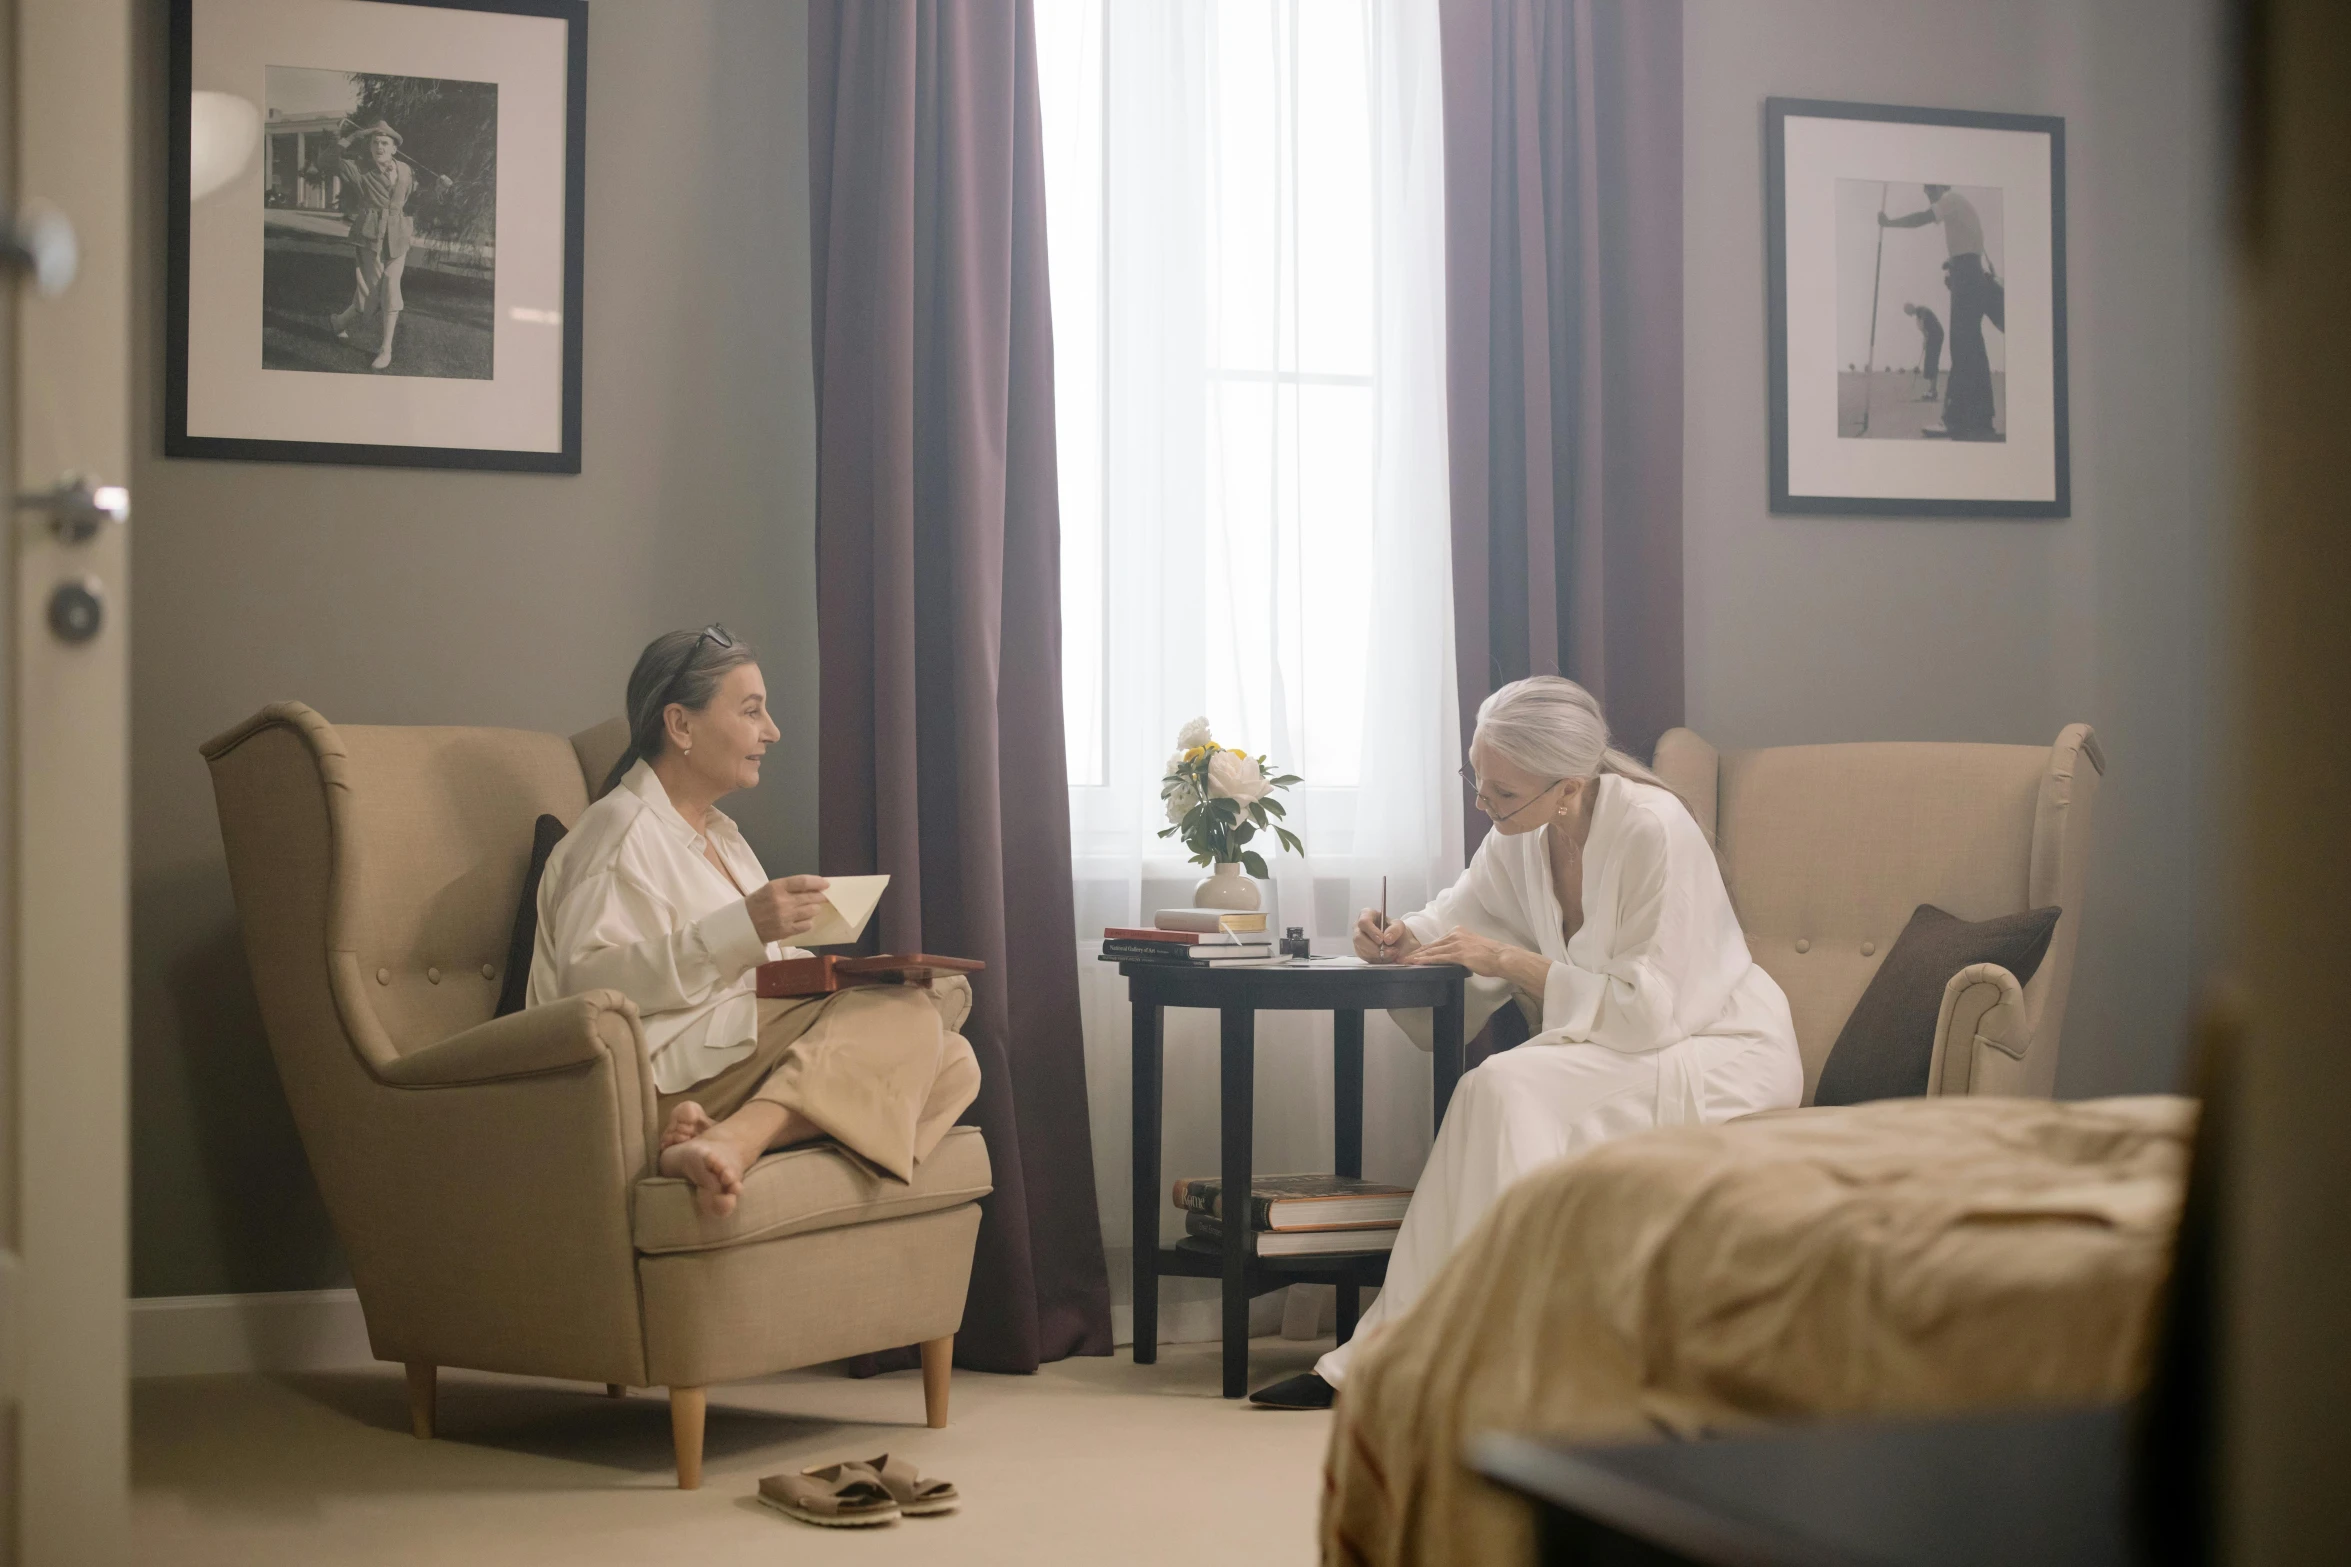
top-left (1655, 724), bottom-right (2106, 1102)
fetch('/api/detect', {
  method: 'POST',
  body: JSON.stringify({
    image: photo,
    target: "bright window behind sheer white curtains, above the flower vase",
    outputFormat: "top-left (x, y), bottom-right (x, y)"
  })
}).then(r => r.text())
top-left (1037, 0), bottom-right (1451, 902)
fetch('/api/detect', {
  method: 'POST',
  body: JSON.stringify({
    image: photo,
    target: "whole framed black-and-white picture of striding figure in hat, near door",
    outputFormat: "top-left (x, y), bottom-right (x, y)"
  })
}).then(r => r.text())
top-left (165, 0), bottom-right (588, 472)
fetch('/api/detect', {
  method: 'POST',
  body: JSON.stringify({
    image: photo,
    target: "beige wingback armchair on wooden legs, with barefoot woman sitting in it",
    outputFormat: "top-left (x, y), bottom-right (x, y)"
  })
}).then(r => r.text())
top-left (190, 702), bottom-right (990, 1489)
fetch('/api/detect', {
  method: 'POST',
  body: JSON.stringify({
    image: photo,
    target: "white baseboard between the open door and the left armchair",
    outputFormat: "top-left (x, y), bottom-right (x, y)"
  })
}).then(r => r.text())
top-left (129, 1290), bottom-right (376, 1377)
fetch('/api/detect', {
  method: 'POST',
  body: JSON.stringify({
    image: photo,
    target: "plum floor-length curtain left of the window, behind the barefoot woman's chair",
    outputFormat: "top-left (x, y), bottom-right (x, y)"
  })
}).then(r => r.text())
top-left (809, 0), bottom-right (1110, 1372)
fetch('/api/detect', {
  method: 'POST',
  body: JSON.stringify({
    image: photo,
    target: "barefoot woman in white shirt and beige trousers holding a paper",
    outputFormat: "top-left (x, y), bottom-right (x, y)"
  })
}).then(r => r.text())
top-left (529, 625), bottom-right (980, 1217)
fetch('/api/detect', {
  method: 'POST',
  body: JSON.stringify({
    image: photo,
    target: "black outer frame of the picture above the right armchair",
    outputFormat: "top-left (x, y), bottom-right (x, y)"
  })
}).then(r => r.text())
top-left (1763, 99), bottom-right (2074, 517)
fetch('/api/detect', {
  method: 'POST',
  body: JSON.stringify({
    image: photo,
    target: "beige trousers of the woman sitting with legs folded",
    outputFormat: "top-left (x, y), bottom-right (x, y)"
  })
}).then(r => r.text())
top-left (661, 975), bottom-right (980, 1182)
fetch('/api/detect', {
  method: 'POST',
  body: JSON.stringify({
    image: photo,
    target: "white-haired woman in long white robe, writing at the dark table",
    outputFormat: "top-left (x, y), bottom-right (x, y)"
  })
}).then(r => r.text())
top-left (1253, 674), bottom-right (1803, 1410)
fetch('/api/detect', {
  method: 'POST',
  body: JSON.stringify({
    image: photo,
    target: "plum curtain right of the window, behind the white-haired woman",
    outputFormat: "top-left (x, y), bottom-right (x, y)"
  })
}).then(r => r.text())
top-left (1439, 0), bottom-right (1681, 846)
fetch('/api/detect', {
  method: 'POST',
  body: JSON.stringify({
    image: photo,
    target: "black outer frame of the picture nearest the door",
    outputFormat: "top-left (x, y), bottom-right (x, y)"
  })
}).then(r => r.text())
top-left (162, 0), bottom-right (588, 475)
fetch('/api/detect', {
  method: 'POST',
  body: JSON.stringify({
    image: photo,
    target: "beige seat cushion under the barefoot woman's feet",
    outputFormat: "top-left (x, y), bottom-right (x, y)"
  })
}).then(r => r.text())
top-left (635, 1125), bottom-right (990, 1255)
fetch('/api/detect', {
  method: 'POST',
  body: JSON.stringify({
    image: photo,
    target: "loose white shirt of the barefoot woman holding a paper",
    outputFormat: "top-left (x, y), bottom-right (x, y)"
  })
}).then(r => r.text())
top-left (529, 761), bottom-right (806, 1092)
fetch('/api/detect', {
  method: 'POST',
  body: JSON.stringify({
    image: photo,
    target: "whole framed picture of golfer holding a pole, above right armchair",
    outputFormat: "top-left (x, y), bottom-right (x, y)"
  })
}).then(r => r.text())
top-left (1763, 99), bottom-right (2071, 517)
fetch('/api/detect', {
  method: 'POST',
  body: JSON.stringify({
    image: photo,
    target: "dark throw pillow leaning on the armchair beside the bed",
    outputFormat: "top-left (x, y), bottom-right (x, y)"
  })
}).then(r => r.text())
top-left (1813, 902), bottom-right (2057, 1104)
